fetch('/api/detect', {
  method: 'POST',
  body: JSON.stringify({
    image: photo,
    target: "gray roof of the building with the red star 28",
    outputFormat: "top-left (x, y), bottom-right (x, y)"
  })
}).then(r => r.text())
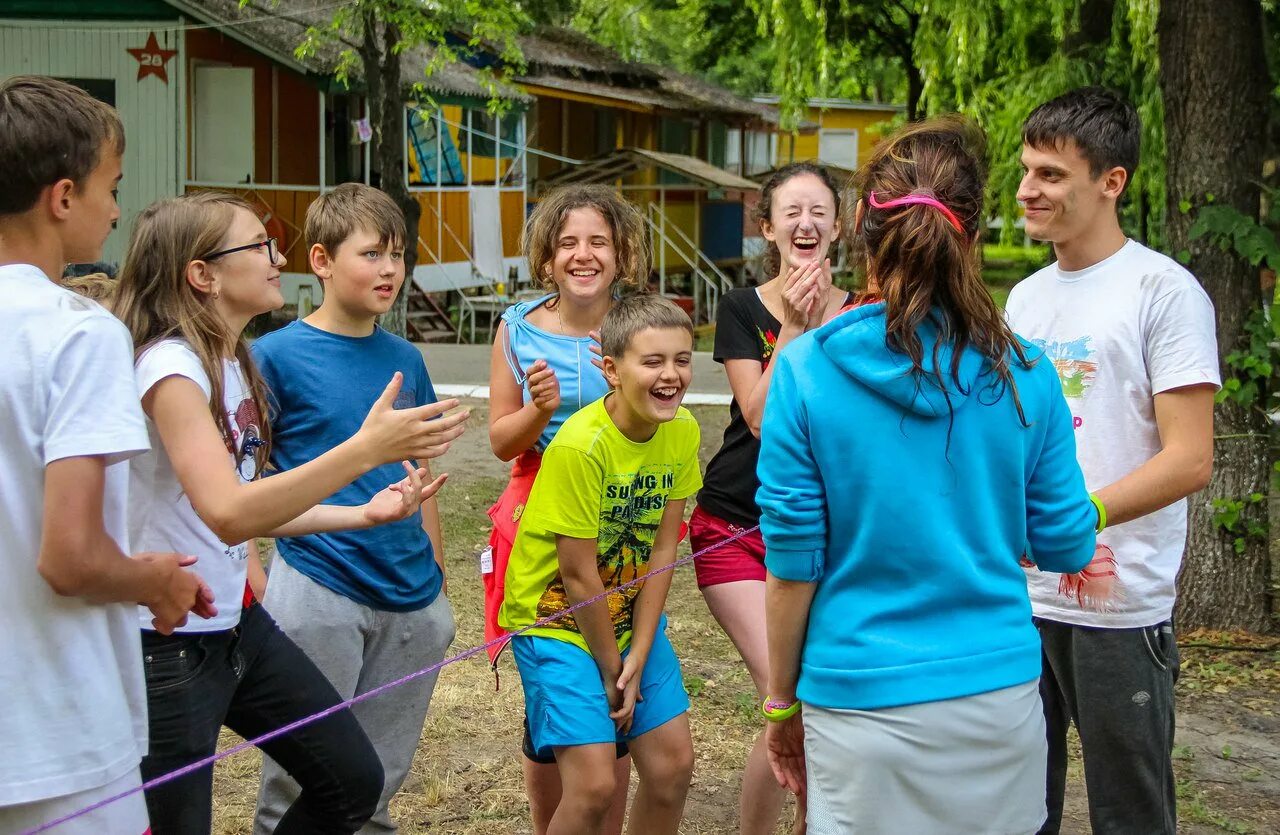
top-left (165, 0), bottom-right (529, 100)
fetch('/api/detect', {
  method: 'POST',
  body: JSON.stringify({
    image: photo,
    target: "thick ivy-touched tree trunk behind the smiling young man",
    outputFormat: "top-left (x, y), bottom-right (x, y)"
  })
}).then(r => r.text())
top-left (1157, 0), bottom-right (1271, 631)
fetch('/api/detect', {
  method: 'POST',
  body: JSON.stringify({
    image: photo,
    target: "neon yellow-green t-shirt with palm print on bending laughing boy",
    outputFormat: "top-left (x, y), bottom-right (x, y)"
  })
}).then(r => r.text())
top-left (498, 394), bottom-right (703, 649)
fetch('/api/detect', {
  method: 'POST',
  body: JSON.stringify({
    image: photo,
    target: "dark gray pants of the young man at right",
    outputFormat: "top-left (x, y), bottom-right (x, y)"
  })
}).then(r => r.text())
top-left (1036, 619), bottom-right (1179, 835)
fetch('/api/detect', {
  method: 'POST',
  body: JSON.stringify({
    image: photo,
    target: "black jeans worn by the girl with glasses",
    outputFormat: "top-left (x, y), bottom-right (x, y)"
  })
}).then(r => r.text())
top-left (142, 603), bottom-right (383, 835)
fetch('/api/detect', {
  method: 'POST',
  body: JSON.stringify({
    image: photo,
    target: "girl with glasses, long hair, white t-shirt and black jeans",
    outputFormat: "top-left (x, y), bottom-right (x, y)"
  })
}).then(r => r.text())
top-left (114, 192), bottom-right (466, 835)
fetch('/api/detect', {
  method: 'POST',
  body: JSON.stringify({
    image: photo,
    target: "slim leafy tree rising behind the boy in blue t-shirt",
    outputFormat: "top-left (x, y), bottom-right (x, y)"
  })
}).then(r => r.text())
top-left (288, 0), bottom-right (529, 336)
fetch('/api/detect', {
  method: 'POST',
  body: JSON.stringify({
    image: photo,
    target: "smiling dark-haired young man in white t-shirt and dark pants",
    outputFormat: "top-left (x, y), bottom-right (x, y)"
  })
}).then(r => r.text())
top-left (1007, 88), bottom-right (1220, 835)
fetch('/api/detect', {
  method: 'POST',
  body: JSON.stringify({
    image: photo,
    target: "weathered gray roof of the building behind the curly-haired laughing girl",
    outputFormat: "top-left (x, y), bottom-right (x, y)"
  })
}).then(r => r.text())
top-left (516, 27), bottom-right (778, 126)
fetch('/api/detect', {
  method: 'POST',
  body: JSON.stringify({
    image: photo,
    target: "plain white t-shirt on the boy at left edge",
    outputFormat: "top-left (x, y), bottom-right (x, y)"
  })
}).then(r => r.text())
top-left (0, 264), bottom-right (147, 806)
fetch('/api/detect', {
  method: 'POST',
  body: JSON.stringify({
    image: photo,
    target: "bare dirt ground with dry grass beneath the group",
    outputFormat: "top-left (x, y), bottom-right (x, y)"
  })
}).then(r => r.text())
top-left (214, 401), bottom-right (1280, 835)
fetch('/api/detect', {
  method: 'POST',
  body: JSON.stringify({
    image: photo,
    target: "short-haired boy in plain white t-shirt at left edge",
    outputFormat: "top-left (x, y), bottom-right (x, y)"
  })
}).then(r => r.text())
top-left (0, 77), bottom-right (214, 835)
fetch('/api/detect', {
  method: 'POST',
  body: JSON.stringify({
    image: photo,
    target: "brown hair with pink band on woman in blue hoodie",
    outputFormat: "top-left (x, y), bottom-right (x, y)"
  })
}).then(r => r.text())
top-left (852, 115), bottom-right (1030, 424)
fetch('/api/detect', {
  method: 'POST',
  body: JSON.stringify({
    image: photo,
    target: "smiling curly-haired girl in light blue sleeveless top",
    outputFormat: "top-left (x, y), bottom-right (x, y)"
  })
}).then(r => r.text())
top-left (480, 186), bottom-right (649, 835)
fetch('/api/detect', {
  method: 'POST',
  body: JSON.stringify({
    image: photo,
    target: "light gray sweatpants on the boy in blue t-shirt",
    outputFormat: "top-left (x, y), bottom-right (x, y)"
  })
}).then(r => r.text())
top-left (253, 556), bottom-right (454, 835)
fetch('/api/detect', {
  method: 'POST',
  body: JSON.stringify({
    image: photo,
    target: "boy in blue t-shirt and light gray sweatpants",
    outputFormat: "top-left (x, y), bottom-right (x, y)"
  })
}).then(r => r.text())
top-left (253, 183), bottom-right (454, 834)
